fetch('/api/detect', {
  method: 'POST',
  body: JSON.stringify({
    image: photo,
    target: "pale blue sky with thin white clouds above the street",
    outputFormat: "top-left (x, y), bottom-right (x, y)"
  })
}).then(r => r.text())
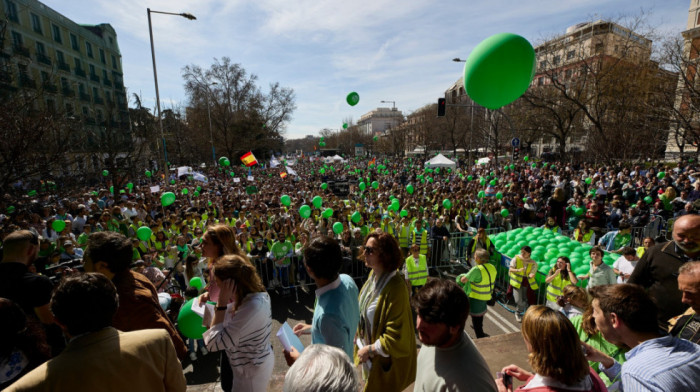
top-left (43, 0), bottom-right (690, 138)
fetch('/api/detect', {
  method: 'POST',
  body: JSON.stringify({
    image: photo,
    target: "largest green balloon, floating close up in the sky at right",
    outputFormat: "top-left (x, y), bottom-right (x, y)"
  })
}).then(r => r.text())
top-left (464, 33), bottom-right (535, 109)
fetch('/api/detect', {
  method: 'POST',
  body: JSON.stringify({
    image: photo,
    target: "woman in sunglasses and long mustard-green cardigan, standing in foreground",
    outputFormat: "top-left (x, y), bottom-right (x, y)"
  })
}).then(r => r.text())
top-left (355, 232), bottom-right (416, 392)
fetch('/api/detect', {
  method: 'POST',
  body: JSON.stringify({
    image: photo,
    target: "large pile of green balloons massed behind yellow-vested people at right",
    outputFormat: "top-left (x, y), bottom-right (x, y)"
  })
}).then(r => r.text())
top-left (490, 227), bottom-right (616, 281)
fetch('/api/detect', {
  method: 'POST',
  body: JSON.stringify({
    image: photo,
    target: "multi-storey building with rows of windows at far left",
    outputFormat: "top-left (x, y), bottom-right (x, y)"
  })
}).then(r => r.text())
top-left (0, 0), bottom-right (129, 170)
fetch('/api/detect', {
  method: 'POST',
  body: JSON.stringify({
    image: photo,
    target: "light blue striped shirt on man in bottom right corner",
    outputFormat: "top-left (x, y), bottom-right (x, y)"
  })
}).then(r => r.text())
top-left (599, 336), bottom-right (700, 392)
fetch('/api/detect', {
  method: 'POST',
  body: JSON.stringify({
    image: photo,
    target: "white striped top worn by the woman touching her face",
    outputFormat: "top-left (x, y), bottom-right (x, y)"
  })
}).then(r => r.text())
top-left (203, 292), bottom-right (274, 374)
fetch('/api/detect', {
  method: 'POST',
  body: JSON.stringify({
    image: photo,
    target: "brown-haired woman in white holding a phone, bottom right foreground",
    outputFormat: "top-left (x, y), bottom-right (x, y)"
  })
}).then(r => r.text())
top-left (496, 305), bottom-right (607, 392)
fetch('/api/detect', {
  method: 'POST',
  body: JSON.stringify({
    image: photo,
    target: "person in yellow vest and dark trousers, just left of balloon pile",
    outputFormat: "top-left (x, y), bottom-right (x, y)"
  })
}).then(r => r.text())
top-left (457, 249), bottom-right (497, 338)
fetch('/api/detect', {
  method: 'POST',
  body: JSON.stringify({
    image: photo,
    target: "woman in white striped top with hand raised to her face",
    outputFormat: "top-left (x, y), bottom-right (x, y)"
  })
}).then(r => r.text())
top-left (203, 254), bottom-right (275, 392)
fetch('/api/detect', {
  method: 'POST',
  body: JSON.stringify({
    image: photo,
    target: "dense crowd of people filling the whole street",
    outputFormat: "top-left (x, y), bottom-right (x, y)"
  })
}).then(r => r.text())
top-left (0, 157), bottom-right (700, 391)
